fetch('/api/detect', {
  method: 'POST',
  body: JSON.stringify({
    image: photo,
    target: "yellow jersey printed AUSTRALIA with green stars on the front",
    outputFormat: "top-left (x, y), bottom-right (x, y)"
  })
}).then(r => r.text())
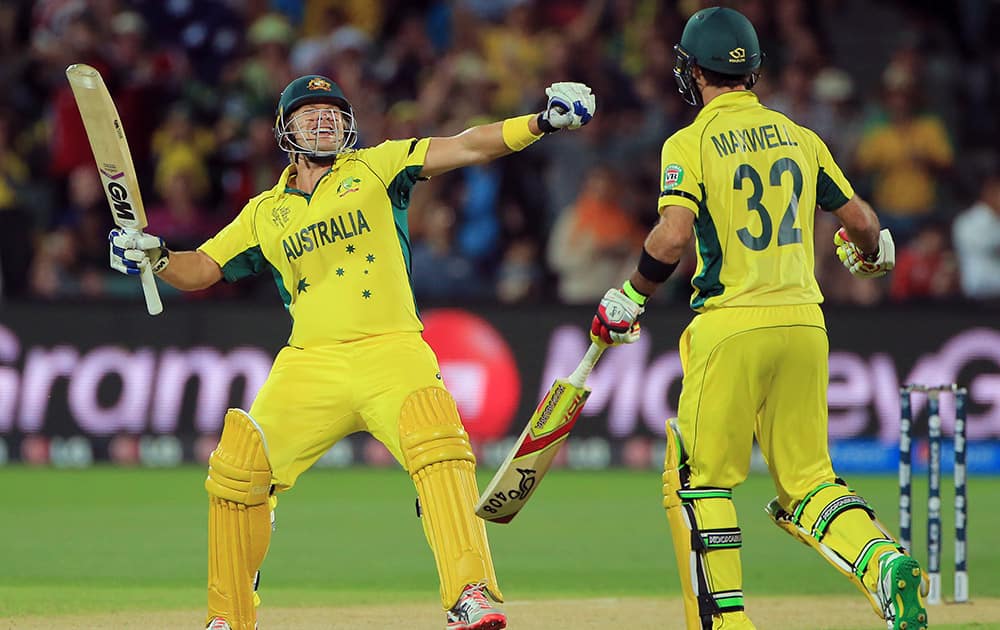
top-left (199, 139), bottom-right (429, 347)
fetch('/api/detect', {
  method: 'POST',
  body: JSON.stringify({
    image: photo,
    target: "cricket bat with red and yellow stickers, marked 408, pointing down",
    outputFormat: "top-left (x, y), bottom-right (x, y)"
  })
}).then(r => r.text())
top-left (476, 343), bottom-right (607, 523)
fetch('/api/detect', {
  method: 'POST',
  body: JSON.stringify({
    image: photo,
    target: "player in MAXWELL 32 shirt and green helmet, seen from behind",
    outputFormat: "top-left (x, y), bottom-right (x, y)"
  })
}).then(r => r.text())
top-left (591, 7), bottom-right (927, 630)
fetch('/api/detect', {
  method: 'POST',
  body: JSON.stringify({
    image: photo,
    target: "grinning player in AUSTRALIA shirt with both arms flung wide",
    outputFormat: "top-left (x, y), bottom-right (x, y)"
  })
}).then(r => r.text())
top-left (111, 75), bottom-right (596, 630)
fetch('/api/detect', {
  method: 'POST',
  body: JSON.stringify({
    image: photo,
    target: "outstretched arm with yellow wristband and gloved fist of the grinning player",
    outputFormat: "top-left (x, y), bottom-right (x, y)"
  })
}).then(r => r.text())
top-left (420, 83), bottom-right (597, 177)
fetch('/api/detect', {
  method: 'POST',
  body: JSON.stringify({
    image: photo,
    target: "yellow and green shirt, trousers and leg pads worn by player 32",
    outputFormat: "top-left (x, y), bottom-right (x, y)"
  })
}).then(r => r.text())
top-left (659, 90), bottom-right (896, 629)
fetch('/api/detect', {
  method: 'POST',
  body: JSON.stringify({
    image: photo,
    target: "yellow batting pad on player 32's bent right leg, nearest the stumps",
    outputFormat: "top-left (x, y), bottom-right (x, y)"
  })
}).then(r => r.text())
top-left (765, 479), bottom-right (905, 617)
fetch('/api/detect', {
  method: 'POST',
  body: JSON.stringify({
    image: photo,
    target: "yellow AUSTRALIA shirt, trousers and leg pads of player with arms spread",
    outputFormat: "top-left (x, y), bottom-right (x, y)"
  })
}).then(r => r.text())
top-left (199, 139), bottom-right (502, 628)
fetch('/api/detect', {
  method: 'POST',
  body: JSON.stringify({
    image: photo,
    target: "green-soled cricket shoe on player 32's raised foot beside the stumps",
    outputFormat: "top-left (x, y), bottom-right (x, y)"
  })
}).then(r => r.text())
top-left (878, 551), bottom-right (927, 630)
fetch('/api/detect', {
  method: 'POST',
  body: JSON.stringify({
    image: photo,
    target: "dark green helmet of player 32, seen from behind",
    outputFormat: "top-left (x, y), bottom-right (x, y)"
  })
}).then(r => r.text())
top-left (674, 7), bottom-right (764, 105)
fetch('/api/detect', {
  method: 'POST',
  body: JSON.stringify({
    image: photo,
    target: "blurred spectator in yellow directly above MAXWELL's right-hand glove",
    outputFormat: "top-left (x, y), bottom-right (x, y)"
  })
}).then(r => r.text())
top-left (857, 66), bottom-right (954, 242)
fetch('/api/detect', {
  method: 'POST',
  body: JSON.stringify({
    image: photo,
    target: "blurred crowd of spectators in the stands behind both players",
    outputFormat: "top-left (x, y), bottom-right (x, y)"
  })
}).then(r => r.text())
top-left (0, 0), bottom-right (1000, 304)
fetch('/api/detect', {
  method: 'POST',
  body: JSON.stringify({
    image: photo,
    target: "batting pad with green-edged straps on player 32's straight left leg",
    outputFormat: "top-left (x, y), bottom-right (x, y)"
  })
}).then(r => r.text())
top-left (663, 422), bottom-right (754, 630)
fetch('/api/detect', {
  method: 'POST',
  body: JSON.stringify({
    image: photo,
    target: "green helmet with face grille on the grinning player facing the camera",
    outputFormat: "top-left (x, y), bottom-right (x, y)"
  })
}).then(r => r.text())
top-left (274, 74), bottom-right (358, 160)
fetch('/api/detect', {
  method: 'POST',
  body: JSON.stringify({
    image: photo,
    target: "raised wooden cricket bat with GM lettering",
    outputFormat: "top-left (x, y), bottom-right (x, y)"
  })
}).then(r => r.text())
top-left (66, 63), bottom-right (163, 315)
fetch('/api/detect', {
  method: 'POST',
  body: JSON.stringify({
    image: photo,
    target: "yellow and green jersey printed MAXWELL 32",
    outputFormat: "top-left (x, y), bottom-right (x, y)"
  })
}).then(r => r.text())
top-left (659, 91), bottom-right (854, 312)
